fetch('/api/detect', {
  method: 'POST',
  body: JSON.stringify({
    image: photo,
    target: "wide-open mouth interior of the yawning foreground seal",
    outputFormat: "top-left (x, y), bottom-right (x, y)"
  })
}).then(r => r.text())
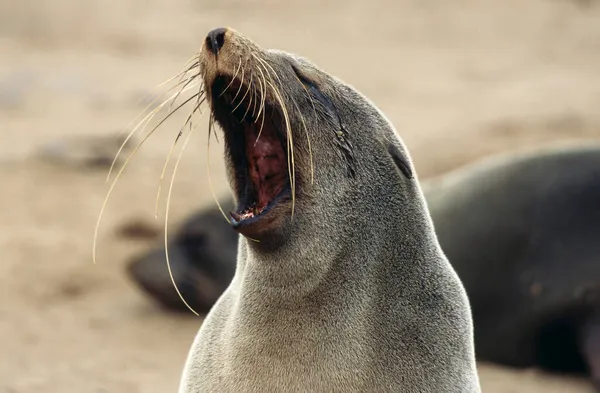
top-left (211, 76), bottom-right (290, 229)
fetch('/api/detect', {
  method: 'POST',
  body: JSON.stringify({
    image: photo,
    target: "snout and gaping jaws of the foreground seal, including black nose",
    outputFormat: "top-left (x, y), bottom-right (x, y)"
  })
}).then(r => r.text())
top-left (199, 28), bottom-right (296, 237)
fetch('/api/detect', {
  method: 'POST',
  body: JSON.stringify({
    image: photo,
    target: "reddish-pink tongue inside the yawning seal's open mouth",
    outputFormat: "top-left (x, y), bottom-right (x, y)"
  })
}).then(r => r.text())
top-left (242, 122), bottom-right (287, 214)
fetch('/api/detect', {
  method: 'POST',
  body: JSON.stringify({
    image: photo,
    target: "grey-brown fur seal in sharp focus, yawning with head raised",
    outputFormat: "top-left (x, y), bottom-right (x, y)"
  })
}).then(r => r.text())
top-left (173, 28), bottom-right (480, 393)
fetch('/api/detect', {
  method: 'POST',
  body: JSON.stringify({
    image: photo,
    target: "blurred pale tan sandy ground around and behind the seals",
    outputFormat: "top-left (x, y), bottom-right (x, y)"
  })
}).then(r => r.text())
top-left (0, 0), bottom-right (600, 393)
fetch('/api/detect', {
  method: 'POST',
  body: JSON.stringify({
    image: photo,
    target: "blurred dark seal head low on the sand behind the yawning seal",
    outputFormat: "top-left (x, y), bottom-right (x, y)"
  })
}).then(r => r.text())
top-left (126, 198), bottom-right (238, 313)
